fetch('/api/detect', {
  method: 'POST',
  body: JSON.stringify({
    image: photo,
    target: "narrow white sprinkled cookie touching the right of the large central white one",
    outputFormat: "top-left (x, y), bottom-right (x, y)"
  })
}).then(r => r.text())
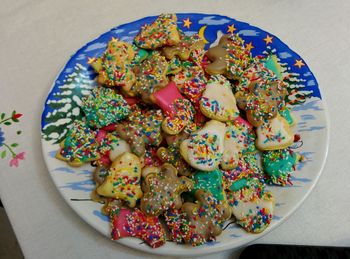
top-left (221, 117), bottom-right (256, 170)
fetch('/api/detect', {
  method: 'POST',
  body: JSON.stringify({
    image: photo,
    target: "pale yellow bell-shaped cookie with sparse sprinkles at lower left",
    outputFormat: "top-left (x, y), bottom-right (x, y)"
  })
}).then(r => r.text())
top-left (96, 153), bottom-right (142, 208)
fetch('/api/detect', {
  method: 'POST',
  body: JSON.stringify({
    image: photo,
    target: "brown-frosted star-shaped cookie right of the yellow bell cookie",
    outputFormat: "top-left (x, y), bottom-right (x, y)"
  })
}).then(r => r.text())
top-left (140, 164), bottom-right (193, 216)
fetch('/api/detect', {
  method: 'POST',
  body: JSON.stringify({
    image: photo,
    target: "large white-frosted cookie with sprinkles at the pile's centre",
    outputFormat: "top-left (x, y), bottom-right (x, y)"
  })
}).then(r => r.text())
top-left (180, 120), bottom-right (226, 171)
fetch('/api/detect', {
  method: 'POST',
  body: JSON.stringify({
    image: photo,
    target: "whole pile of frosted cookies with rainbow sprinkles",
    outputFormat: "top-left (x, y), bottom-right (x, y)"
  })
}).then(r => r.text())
top-left (56, 14), bottom-right (300, 247)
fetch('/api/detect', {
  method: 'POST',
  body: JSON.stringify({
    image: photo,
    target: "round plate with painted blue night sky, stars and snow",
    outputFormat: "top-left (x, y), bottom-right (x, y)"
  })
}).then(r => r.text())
top-left (41, 13), bottom-right (328, 255)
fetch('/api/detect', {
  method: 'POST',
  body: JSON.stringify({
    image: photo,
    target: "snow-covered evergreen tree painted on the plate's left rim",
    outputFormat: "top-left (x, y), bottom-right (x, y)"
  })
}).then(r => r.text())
top-left (42, 63), bottom-right (97, 144)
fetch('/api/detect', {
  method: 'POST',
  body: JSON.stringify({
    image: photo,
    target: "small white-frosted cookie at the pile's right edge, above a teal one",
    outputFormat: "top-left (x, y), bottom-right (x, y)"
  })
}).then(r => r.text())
top-left (255, 114), bottom-right (294, 150)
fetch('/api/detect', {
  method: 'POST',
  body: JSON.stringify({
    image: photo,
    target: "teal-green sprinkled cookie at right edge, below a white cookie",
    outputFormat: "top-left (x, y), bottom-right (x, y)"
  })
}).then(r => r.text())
top-left (262, 148), bottom-right (301, 186)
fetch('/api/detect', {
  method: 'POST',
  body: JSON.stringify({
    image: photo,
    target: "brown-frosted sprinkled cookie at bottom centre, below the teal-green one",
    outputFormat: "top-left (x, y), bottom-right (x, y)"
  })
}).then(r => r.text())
top-left (181, 190), bottom-right (231, 246)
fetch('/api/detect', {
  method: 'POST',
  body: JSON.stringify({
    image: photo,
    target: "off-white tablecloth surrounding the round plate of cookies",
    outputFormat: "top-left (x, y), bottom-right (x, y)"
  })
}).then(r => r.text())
top-left (0, 0), bottom-right (350, 259)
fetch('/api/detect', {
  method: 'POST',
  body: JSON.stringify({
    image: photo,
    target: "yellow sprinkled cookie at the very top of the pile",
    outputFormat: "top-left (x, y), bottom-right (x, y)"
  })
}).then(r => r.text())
top-left (134, 14), bottom-right (180, 49)
